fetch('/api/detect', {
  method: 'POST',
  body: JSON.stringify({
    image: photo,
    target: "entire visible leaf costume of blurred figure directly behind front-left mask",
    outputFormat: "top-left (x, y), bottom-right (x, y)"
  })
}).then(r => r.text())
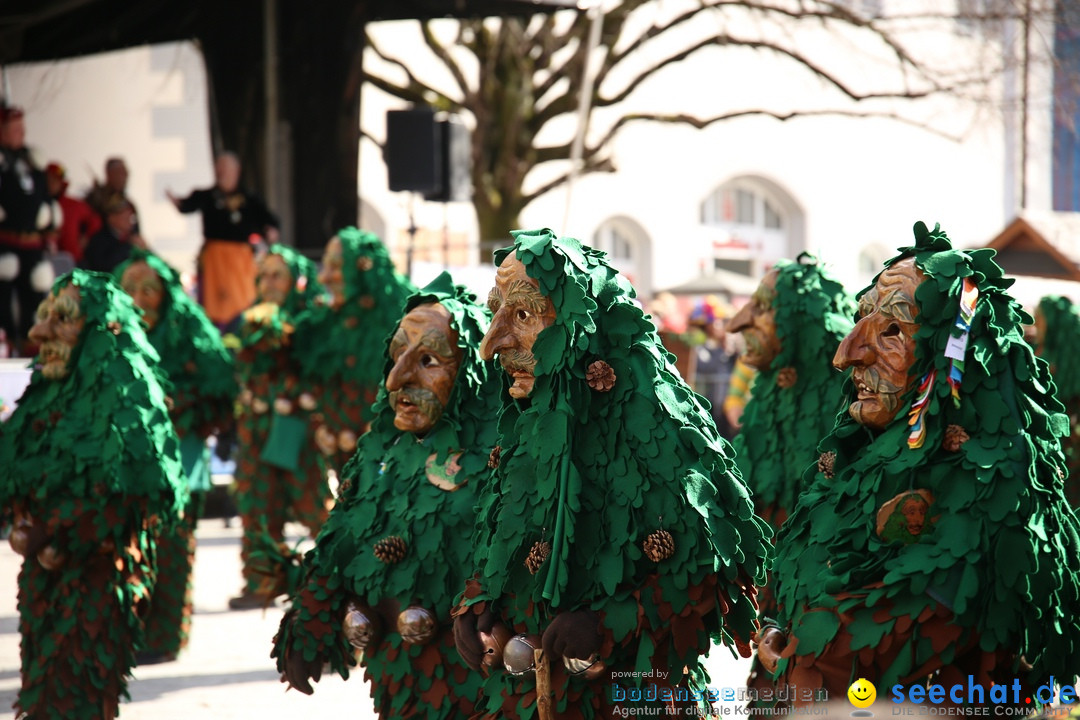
top-left (294, 228), bottom-right (416, 472)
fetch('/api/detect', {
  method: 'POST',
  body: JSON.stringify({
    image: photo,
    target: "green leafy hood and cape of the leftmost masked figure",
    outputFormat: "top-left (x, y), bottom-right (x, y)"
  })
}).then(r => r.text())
top-left (0, 270), bottom-right (186, 524)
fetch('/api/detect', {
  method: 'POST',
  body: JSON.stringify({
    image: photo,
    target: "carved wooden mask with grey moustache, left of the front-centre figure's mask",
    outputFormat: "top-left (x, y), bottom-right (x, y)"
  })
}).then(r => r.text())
top-left (387, 303), bottom-right (462, 435)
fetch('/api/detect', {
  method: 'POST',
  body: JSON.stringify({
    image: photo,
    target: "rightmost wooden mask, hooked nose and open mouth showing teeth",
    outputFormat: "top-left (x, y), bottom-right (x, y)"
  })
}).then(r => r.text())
top-left (833, 258), bottom-right (926, 430)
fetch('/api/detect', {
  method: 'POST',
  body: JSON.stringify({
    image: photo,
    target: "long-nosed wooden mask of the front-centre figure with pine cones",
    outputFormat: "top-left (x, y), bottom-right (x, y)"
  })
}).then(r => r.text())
top-left (480, 253), bottom-right (555, 399)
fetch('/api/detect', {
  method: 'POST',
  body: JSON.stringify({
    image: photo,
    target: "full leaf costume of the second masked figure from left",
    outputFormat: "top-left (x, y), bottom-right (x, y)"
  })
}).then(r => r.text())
top-left (113, 248), bottom-right (238, 656)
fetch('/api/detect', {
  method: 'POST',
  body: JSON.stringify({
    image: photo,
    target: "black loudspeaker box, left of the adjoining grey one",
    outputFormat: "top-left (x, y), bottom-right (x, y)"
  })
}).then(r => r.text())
top-left (386, 108), bottom-right (444, 194)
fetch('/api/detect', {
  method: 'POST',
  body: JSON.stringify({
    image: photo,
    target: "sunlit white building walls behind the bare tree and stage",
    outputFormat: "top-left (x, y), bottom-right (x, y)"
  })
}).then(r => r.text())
top-left (6, 2), bottom-right (1049, 297)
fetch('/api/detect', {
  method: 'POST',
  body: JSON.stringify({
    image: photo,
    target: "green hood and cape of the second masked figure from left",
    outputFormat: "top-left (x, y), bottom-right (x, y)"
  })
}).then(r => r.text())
top-left (113, 248), bottom-right (238, 437)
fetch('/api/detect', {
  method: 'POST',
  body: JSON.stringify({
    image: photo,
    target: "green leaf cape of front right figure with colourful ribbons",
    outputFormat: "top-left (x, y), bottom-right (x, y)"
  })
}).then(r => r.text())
top-left (774, 222), bottom-right (1080, 687)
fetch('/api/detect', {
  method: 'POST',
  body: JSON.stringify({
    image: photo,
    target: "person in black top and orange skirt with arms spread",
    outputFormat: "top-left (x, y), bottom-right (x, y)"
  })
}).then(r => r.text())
top-left (165, 152), bottom-right (278, 329)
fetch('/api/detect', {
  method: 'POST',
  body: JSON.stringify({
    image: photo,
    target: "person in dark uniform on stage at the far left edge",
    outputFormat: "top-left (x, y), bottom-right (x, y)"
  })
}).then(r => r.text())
top-left (0, 104), bottom-right (58, 355)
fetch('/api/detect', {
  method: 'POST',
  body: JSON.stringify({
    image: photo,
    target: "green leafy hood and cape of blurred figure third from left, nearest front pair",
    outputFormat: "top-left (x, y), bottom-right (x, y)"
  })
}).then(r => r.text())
top-left (294, 228), bottom-right (416, 388)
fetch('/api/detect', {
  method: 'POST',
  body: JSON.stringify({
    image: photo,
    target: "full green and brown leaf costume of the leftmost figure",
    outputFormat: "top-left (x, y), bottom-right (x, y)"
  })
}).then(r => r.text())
top-left (0, 270), bottom-right (187, 719)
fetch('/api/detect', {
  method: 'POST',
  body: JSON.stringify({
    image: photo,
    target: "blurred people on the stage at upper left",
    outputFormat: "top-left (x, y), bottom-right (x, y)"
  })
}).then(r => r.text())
top-left (0, 105), bottom-right (279, 358)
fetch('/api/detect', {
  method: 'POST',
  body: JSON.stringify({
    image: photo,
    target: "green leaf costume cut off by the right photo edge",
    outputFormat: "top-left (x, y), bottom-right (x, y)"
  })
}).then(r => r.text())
top-left (1035, 296), bottom-right (1080, 507)
